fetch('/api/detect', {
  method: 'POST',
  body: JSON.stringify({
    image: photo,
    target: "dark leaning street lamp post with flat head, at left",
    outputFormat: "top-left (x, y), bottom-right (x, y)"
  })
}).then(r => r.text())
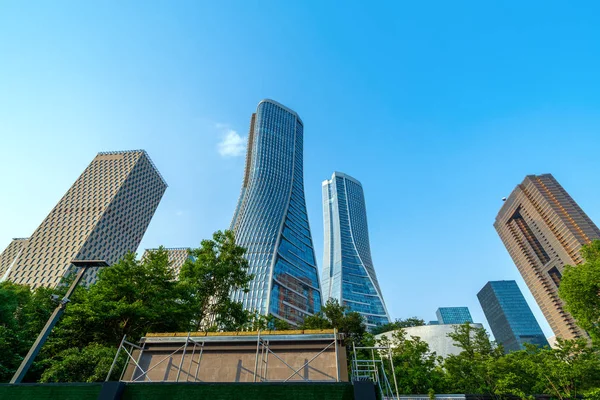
top-left (10, 260), bottom-right (108, 383)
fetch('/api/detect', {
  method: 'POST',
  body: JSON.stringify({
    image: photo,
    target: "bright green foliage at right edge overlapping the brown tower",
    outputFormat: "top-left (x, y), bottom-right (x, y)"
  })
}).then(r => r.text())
top-left (558, 240), bottom-right (600, 345)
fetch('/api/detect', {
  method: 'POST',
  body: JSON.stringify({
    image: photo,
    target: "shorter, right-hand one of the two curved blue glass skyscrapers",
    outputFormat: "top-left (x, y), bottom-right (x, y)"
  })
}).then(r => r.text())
top-left (322, 172), bottom-right (390, 327)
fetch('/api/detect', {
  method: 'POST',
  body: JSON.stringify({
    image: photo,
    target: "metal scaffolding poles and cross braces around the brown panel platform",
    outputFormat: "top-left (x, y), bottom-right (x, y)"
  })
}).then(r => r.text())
top-left (106, 330), bottom-right (341, 383)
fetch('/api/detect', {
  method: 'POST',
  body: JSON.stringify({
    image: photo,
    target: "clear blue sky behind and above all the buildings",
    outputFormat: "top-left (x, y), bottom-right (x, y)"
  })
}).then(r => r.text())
top-left (0, 0), bottom-right (600, 335)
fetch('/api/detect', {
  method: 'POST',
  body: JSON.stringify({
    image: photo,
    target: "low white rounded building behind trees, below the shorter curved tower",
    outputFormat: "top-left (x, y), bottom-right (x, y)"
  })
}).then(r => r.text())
top-left (375, 324), bottom-right (483, 358)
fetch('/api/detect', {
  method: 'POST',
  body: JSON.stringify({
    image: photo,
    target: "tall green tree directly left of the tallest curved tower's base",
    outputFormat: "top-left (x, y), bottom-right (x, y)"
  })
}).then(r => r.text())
top-left (179, 231), bottom-right (252, 330)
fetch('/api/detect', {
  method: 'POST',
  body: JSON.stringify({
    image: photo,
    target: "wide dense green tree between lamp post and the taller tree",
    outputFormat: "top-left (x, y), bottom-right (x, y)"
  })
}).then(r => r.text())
top-left (48, 247), bottom-right (193, 350)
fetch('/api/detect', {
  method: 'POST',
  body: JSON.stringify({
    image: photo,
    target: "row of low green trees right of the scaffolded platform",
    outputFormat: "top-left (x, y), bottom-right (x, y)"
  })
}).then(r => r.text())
top-left (370, 324), bottom-right (600, 399)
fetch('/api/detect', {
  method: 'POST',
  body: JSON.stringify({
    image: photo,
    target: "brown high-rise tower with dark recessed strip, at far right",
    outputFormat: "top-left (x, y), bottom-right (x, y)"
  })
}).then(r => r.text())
top-left (494, 174), bottom-right (600, 339)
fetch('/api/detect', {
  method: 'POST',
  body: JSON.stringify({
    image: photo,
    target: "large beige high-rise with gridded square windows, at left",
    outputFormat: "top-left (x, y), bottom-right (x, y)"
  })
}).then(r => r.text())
top-left (5, 150), bottom-right (167, 288)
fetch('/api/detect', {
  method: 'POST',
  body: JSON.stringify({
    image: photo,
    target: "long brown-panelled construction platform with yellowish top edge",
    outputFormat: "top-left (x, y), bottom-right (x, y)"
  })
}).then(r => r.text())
top-left (115, 329), bottom-right (348, 383)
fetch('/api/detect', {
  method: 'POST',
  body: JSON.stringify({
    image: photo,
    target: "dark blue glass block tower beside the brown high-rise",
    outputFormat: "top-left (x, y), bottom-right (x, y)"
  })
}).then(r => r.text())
top-left (477, 281), bottom-right (548, 352)
